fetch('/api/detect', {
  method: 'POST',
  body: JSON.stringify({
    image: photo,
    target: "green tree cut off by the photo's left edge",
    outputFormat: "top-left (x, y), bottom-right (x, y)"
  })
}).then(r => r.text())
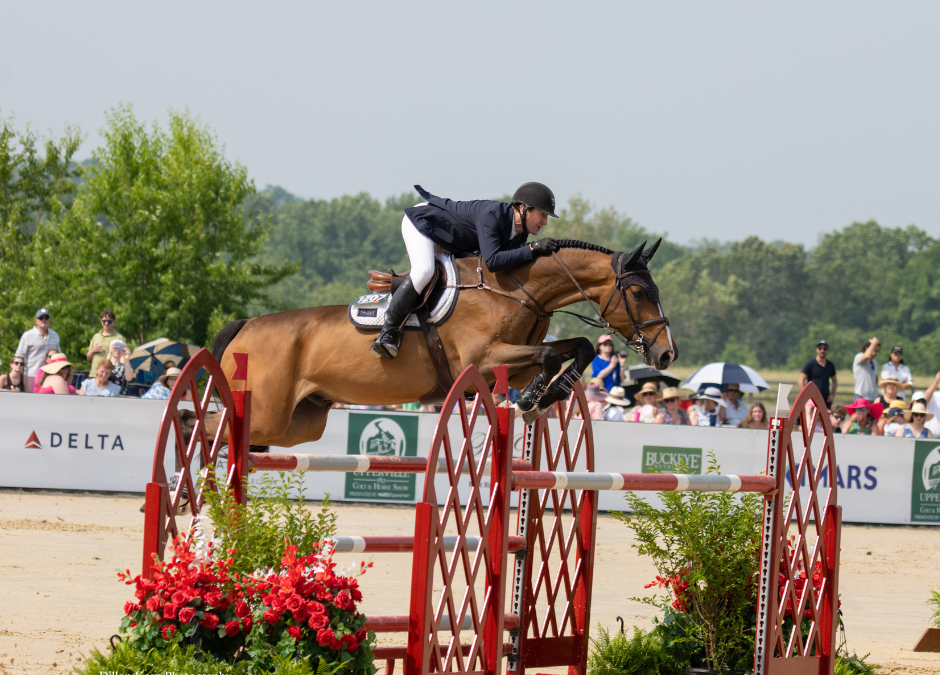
top-left (0, 113), bottom-right (82, 363)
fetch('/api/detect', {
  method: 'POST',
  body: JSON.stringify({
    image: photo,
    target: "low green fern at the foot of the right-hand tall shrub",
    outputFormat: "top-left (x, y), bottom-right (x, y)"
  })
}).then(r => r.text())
top-left (588, 625), bottom-right (688, 675)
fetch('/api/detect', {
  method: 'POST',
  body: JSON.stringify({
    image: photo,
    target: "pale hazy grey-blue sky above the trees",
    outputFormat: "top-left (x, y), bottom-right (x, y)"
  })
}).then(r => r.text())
top-left (0, 1), bottom-right (940, 244)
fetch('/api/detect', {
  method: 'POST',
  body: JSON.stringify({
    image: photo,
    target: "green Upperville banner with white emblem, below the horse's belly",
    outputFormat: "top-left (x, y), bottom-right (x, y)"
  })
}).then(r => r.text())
top-left (345, 412), bottom-right (418, 502)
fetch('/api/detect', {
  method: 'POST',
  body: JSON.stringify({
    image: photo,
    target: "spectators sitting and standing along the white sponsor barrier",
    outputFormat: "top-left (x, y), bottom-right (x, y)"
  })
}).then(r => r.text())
top-left (0, 308), bottom-right (940, 439)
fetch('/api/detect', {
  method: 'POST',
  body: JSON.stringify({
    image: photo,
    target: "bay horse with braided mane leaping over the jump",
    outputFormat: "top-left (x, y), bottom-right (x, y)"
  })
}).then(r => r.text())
top-left (207, 239), bottom-right (678, 447)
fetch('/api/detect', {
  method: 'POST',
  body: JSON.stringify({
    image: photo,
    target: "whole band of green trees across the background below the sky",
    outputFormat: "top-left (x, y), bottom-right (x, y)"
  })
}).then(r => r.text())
top-left (0, 107), bottom-right (940, 374)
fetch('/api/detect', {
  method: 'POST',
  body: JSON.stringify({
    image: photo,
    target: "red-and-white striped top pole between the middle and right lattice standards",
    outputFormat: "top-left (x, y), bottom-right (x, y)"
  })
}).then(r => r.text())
top-left (513, 471), bottom-right (777, 492)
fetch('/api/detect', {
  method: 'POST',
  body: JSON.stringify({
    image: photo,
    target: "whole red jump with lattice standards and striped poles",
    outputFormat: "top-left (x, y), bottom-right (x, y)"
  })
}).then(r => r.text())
top-left (143, 350), bottom-right (841, 675)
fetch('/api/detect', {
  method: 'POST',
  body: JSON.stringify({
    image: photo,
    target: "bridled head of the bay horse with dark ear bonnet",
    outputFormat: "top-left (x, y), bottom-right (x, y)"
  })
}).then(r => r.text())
top-left (605, 239), bottom-right (679, 370)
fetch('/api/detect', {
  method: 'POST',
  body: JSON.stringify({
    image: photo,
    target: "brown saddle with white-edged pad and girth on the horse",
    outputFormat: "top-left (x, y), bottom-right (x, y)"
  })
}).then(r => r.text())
top-left (349, 251), bottom-right (460, 405)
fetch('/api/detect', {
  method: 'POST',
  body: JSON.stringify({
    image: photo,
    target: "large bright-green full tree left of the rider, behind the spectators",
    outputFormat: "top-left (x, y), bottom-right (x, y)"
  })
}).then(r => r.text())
top-left (76, 106), bottom-right (296, 345)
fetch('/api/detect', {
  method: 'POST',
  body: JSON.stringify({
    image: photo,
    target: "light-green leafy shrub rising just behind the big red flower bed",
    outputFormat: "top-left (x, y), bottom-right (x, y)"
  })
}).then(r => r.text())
top-left (204, 472), bottom-right (336, 574)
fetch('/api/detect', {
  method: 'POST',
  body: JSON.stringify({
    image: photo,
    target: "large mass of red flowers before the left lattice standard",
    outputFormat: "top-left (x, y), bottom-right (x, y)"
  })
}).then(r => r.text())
top-left (118, 536), bottom-right (375, 672)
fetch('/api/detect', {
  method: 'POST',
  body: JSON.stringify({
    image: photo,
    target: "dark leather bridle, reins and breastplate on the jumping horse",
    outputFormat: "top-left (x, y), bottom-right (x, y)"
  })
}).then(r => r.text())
top-left (449, 252), bottom-right (678, 360)
